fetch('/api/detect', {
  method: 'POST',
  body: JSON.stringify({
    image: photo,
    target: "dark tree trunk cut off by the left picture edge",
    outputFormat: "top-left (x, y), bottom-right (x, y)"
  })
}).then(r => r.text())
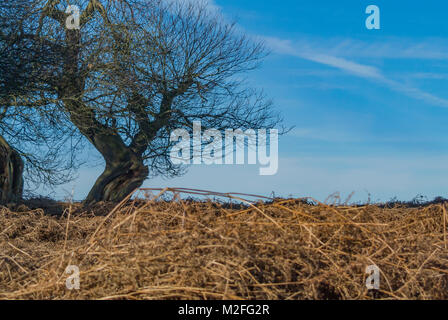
top-left (0, 136), bottom-right (23, 205)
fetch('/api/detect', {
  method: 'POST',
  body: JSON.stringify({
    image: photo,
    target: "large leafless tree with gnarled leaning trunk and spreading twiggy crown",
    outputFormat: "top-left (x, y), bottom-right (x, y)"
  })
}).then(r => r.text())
top-left (23, 0), bottom-right (281, 203)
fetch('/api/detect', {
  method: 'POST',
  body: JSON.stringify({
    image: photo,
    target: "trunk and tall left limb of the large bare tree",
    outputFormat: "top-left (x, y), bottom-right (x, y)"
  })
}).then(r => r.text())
top-left (59, 30), bottom-right (149, 205)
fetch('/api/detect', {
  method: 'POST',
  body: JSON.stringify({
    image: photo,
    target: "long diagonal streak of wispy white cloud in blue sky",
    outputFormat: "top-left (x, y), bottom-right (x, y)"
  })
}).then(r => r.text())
top-left (263, 37), bottom-right (448, 108)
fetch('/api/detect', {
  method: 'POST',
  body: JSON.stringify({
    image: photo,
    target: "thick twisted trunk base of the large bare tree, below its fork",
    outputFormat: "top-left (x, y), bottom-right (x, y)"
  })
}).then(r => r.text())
top-left (85, 157), bottom-right (149, 204)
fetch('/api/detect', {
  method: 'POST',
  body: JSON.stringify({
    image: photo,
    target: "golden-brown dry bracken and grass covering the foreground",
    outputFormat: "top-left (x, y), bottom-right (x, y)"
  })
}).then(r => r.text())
top-left (0, 190), bottom-right (448, 299)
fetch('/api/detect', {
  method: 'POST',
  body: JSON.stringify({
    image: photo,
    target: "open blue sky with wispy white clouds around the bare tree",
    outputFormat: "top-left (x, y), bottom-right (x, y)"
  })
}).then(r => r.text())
top-left (51, 0), bottom-right (448, 201)
